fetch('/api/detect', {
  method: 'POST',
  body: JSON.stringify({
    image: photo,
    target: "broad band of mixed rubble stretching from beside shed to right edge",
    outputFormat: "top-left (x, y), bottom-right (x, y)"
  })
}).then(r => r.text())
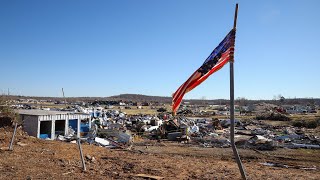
top-left (64, 110), bottom-right (320, 151)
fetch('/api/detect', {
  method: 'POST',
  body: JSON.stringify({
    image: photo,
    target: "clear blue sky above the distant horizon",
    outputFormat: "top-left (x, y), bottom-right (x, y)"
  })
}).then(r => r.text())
top-left (0, 0), bottom-right (320, 99)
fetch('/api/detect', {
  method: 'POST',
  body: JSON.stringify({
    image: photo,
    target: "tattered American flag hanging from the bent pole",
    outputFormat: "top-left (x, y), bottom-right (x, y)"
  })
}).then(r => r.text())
top-left (172, 29), bottom-right (236, 113)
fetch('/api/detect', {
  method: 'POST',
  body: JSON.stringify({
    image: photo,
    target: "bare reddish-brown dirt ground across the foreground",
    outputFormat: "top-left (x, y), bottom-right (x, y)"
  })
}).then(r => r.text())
top-left (0, 128), bottom-right (320, 180)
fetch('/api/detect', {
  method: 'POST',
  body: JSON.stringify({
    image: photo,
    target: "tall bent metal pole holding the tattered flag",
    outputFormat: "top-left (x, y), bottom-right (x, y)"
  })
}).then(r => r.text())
top-left (230, 3), bottom-right (247, 179)
